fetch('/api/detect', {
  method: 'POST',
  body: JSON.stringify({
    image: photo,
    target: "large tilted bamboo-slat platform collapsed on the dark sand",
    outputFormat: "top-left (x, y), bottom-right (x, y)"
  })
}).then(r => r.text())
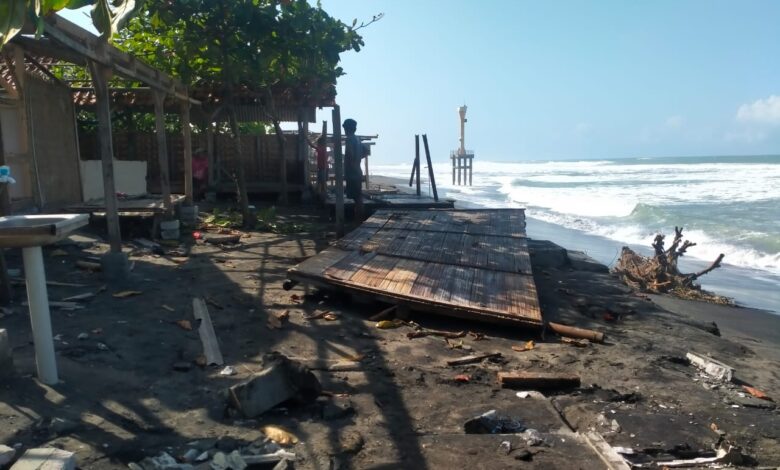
top-left (288, 209), bottom-right (542, 327)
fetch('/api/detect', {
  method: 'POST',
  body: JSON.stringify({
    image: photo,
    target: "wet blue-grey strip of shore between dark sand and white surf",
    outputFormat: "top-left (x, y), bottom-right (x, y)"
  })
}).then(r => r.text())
top-left (371, 174), bottom-right (780, 318)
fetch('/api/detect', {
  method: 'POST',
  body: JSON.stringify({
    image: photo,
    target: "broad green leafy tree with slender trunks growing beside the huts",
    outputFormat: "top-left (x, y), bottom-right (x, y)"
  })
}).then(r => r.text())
top-left (118, 0), bottom-right (379, 224)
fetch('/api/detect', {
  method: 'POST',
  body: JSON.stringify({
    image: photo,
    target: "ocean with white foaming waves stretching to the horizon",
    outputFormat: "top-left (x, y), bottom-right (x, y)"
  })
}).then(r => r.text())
top-left (371, 156), bottom-right (780, 313)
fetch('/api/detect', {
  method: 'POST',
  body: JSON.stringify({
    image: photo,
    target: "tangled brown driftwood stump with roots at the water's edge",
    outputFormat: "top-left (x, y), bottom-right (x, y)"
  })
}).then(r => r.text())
top-left (613, 227), bottom-right (731, 304)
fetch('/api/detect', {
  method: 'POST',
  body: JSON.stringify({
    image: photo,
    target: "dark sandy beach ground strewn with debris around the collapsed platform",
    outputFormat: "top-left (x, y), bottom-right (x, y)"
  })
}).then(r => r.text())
top-left (0, 196), bottom-right (780, 469)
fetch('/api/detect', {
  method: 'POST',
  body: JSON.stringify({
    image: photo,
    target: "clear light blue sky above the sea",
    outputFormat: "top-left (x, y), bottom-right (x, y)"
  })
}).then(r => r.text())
top-left (62, 0), bottom-right (780, 164)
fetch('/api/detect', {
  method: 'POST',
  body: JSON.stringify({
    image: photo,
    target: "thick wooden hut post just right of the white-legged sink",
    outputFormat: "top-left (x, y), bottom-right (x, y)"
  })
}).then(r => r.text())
top-left (89, 61), bottom-right (122, 253)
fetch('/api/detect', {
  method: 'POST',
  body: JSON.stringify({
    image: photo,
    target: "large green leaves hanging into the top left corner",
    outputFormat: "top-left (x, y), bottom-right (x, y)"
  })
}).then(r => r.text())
top-left (0, 0), bottom-right (143, 47)
